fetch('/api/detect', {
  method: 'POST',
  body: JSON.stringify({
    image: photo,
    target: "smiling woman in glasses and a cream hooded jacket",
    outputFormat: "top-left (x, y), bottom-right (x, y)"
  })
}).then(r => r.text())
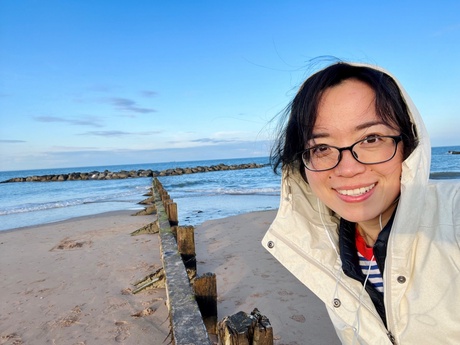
top-left (263, 62), bottom-right (460, 345)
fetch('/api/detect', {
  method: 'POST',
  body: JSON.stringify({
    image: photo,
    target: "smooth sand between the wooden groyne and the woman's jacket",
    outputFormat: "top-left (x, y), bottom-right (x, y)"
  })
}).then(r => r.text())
top-left (195, 211), bottom-right (340, 345)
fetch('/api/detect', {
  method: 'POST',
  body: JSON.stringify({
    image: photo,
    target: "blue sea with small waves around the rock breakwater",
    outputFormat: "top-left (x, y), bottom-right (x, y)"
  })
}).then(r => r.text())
top-left (0, 146), bottom-right (460, 230)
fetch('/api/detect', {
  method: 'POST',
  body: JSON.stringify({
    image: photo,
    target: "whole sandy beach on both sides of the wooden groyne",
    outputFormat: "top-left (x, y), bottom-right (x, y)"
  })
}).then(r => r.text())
top-left (0, 207), bottom-right (339, 345)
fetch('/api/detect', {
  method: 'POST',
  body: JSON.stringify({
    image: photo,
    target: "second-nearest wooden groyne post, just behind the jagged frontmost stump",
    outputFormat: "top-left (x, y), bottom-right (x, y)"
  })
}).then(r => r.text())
top-left (193, 273), bottom-right (217, 335)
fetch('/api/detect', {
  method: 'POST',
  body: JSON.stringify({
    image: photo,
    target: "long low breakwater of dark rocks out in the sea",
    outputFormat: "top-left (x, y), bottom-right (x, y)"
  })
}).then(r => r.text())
top-left (0, 163), bottom-right (267, 183)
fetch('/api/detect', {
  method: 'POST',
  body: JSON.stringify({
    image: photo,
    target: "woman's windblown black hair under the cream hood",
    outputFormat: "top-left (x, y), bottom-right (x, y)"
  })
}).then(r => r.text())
top-left (270, 62), bottom-right (417, 175)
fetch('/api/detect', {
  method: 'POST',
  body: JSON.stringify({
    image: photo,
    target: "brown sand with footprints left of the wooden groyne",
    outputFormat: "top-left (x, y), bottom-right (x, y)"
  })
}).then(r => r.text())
top-left (0, 212), bottom-right (169, 345)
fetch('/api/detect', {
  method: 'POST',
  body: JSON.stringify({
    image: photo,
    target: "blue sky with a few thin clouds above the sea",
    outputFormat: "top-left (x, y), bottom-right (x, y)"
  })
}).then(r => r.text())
top-left (0, 0), bottom-right (460, 171)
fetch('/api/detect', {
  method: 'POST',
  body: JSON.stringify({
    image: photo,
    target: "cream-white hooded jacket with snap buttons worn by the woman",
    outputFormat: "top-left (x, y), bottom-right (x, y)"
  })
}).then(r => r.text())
top-left (262, 66), bottom-right (460, 345)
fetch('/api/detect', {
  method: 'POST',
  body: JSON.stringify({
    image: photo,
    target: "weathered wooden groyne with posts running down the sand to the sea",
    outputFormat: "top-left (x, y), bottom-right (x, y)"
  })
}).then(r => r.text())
top-left (152, 178), bottom-right (273, 345)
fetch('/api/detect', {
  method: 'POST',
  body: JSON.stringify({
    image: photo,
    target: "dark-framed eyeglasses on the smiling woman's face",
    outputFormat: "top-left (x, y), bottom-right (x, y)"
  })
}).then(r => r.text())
top-left (301, 135), bottom-right (402, 171)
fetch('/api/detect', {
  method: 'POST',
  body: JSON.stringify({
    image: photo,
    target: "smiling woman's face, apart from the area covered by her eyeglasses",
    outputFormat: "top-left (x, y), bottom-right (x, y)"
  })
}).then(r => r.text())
top-left (305, 79), bottom-right (403, 224)
